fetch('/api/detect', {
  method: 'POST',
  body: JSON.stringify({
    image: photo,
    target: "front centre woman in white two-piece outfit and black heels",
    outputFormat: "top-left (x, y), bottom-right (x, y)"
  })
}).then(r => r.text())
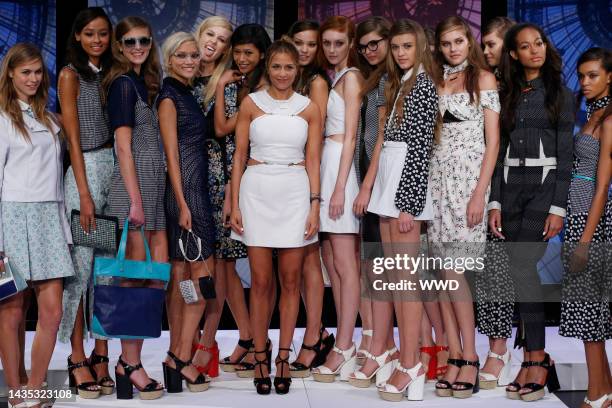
top-left (231, 40), bottom-right (321, 394)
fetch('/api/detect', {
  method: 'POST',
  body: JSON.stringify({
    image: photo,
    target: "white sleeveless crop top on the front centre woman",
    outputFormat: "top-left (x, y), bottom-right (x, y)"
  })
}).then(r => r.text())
top-left (249, 90), bottom-right (310, 165)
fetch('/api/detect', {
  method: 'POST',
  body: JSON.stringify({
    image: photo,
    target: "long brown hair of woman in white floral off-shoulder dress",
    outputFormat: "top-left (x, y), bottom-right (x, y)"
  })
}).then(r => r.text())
top-left (435, 16), bottom-right (488, 103)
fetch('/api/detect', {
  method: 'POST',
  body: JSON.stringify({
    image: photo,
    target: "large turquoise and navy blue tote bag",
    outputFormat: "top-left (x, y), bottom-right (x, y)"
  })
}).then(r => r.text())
top-left (91, 219), bottom-right (170, 339)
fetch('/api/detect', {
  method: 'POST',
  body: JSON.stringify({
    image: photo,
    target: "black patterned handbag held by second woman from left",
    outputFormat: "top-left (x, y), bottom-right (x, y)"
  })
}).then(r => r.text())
top-left (70, 210), bottom-right (120, 252)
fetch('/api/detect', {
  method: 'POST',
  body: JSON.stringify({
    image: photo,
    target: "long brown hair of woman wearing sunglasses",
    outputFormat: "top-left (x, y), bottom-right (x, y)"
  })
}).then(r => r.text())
top-left (102, 16), bottom-right (162, 105)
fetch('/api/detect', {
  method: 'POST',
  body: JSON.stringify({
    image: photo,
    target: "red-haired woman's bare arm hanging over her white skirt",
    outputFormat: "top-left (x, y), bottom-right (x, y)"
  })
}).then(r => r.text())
top-left (329, 71), bottom-right (363, 220)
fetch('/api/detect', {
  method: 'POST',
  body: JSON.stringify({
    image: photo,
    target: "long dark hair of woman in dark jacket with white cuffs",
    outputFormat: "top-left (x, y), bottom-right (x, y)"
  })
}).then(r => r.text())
top-left (500, 23), bottom-right (563, 135)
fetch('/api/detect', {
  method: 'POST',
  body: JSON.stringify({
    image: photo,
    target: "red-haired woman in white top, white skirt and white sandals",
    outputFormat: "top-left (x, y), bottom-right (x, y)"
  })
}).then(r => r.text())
top-left (312, 16), bottom-right (363, 382)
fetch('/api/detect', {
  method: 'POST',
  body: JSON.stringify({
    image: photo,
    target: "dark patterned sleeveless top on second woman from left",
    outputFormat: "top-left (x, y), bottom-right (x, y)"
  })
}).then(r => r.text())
top-left (59, 64), bottom-right (112, 152)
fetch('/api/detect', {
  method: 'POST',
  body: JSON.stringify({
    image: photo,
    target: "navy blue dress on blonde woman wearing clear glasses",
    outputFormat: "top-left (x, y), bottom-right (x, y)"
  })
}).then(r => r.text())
top-left (157, 77), bottom-right (215, 260)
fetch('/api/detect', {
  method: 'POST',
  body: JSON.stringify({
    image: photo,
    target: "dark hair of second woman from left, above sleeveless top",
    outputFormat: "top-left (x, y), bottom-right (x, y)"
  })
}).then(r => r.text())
top-left (66, 7), bottom-right (113, 81)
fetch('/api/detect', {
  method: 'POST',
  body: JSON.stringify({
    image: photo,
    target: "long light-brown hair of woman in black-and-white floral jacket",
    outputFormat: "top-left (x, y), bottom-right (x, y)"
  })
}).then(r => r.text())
top-left (385, 18), bottom-right (438, 119)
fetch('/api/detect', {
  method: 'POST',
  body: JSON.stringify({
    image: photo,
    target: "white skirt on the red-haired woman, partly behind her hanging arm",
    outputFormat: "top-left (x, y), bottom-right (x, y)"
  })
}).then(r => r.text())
top-left (319, 138), bottom-right (359, 234)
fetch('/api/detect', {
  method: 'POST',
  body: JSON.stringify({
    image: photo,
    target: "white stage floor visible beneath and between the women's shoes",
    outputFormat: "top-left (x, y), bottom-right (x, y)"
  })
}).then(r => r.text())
top-left (0, 327), bottom-right (612, 408)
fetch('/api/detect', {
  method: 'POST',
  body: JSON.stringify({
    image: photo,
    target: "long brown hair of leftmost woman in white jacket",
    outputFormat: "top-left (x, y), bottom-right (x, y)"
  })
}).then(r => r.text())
top-left (0, 43), bottom-right (57, 142)
